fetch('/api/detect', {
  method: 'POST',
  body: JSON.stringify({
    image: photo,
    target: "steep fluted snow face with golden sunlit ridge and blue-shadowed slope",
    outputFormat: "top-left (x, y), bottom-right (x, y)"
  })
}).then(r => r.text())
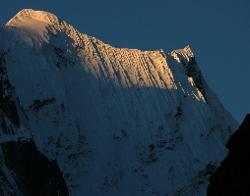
top-left (0, 10), bottom-right (237, 196)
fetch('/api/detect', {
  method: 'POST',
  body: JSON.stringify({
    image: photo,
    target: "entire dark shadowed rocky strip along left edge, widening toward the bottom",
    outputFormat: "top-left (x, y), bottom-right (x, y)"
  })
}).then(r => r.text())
top-left (0, 51), bottom-right (69, 196)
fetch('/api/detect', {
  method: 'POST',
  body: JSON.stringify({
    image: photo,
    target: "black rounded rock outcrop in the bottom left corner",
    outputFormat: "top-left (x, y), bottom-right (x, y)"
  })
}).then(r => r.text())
top-left (1, 141), bottom-right (69, 196)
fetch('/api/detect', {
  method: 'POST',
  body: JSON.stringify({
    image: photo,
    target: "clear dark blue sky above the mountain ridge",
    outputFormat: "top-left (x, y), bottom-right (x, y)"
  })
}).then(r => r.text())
top-left (0, 0), bottom-right (250, 121)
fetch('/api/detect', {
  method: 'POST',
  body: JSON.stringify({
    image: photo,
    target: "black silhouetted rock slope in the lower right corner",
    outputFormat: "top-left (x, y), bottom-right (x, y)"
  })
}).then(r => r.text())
top-left (207, 114), bottom-right (250, 196)
